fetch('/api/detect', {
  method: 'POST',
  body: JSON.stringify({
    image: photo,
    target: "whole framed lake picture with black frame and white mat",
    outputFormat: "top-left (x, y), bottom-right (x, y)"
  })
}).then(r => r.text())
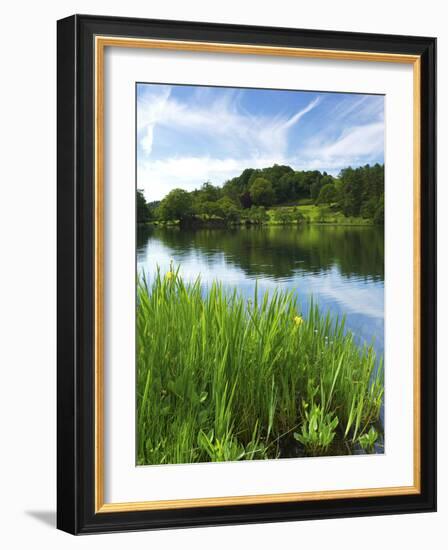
top-left (57, 15), bottom-right (436, 534)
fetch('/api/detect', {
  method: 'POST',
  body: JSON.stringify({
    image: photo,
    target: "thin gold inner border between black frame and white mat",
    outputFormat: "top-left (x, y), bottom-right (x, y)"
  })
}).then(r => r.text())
top-left (94, 36), bottom-right (421, 513)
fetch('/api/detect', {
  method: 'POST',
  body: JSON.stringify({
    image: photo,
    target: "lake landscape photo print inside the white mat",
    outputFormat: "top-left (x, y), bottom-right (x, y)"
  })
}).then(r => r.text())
top-left (136, 83), bottom-right (386, 466)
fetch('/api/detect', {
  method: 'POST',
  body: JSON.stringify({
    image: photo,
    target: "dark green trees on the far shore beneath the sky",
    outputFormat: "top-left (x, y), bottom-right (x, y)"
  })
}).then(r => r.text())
top-left (137, 164), bottom-right (384, 224)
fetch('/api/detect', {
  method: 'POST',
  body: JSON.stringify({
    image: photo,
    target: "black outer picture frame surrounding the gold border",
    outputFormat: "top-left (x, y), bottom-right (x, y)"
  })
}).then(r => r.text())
top-left (57, 15), bottom-right (436, 534)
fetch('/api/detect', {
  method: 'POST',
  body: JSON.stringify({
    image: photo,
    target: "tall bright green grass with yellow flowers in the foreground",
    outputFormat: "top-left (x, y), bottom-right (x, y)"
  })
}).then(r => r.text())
top-left (137, 271), bottom-right (383, 464)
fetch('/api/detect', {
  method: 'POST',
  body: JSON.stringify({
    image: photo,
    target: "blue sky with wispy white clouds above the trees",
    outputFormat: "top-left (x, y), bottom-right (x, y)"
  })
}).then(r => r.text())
top-left (137, 84), bottom-right (384, 201)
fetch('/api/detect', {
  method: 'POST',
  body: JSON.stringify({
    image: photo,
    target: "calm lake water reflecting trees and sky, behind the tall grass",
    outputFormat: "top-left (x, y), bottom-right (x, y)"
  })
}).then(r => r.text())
top-left (137, 225), bottom-right (384, 362)
